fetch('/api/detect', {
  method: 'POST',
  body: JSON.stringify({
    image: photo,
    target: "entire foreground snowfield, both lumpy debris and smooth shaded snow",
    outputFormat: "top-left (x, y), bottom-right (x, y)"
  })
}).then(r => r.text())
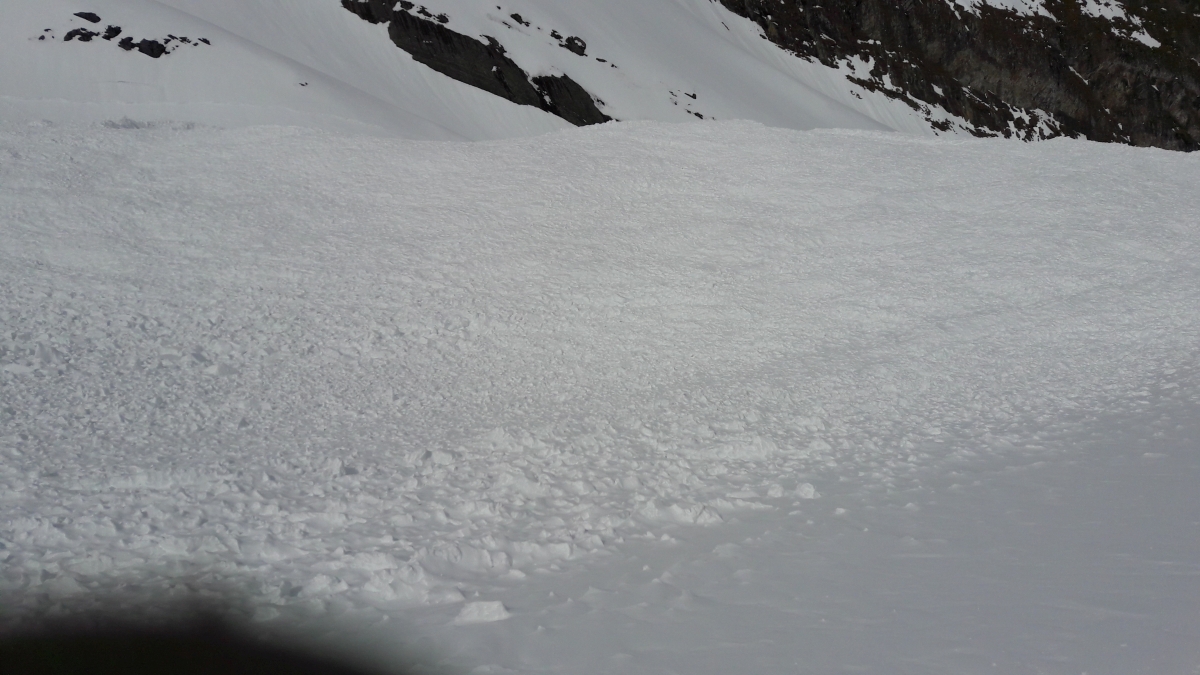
top-left (0, 120), bottom-right (1200, 675)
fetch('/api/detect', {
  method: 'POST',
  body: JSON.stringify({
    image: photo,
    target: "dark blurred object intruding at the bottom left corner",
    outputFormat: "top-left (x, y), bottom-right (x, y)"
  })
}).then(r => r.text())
top-left (0, 620), bottom-right (388, 675)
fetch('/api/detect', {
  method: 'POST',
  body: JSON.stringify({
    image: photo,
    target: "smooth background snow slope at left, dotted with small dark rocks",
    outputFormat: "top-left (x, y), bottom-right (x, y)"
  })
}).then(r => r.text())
top-left (0, 0), bottom-right (569, 139)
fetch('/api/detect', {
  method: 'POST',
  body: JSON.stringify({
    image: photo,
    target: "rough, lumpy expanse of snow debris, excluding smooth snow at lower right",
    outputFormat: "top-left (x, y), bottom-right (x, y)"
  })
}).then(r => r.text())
top-left (0, 123), bottom-right (1200, 622)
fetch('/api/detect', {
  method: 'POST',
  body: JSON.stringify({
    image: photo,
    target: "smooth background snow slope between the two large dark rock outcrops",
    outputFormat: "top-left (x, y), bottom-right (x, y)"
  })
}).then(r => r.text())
top-left (319, 0), bottom-right (916, 135)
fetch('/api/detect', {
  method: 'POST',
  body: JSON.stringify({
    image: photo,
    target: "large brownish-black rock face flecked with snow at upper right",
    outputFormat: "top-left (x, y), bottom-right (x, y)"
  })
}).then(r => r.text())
top-left (720, 0), bottom-right (1200, 150)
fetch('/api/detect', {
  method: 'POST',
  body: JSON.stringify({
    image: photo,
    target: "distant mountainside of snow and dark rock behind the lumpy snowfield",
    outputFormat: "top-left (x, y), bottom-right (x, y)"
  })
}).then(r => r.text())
top-left (7, 0), bottom-right (1200, 150)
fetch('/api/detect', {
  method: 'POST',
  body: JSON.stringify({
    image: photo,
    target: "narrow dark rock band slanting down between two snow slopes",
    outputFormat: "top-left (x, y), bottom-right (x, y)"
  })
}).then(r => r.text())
top-left (342, 0), bottom-right (611, 126)
